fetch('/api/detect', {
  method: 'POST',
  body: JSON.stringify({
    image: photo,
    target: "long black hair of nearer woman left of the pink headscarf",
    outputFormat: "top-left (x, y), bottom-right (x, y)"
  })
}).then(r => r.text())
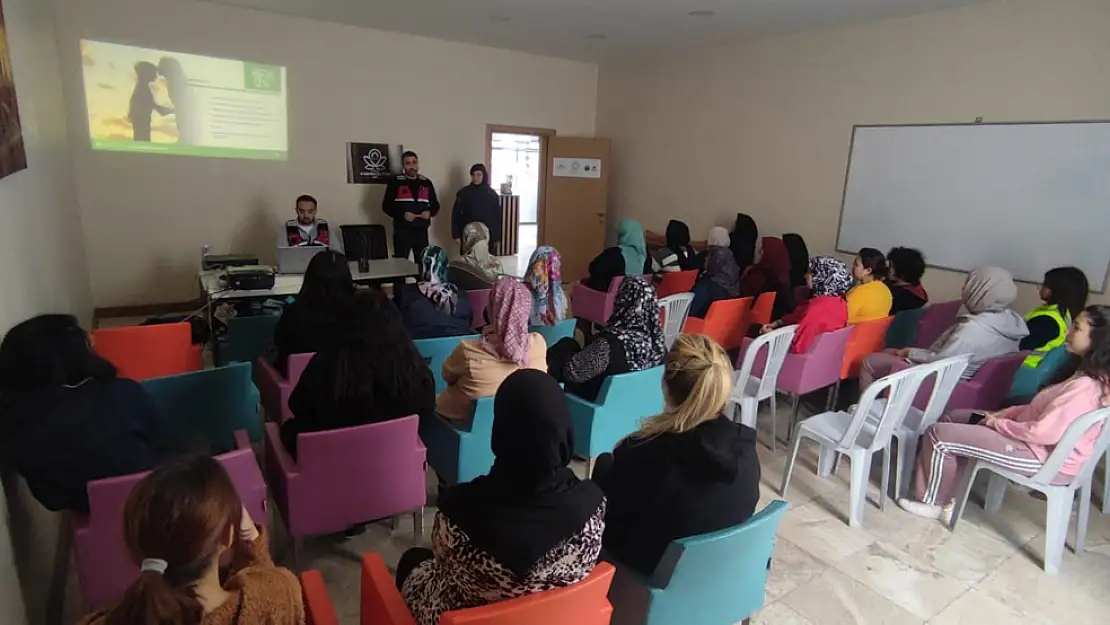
top-left (332, 290), bottom-right (435, 402)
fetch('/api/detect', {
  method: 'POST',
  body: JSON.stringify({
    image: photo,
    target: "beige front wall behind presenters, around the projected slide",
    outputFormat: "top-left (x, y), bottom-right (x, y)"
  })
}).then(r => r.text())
top-left (54, 0), bottom-right (597, 306)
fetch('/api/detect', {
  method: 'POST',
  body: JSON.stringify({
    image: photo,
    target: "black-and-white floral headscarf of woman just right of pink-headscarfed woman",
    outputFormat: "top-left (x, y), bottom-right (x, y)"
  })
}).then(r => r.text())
top-left (605, 278), bottom-right (667, 371)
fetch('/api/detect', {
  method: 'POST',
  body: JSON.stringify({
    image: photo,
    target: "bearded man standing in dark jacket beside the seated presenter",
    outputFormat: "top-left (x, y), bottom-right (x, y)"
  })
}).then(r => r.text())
top-left (382, 151), bottom-right (440, 261)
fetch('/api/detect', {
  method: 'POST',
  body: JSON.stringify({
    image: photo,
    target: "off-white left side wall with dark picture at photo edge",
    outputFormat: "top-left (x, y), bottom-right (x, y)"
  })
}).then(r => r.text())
top-left (0, 0), bottom-right (92, 625)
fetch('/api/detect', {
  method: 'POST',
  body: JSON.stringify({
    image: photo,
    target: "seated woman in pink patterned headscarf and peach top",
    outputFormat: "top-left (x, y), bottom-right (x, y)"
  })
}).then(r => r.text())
top-left (435, 278), bottom-right (547, 421)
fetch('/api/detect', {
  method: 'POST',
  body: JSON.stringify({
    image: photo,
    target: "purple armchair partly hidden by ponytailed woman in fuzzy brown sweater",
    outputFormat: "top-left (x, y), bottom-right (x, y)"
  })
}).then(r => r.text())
top-left (71, 430), bottom-right (270, 611)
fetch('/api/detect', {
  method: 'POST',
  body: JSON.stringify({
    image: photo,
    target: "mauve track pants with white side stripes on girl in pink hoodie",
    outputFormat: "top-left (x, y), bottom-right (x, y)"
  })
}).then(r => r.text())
top-left (914, 411), bottom-right (1041, 505)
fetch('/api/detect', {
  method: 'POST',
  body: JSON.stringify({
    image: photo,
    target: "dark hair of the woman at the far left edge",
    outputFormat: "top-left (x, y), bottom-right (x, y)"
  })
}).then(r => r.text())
top-left (0, 314), bottom-right (115, 397)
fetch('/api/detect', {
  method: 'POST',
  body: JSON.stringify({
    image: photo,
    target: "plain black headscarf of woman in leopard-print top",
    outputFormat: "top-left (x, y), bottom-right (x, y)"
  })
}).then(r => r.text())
top-left (440, 369), bottom-right (603, 577)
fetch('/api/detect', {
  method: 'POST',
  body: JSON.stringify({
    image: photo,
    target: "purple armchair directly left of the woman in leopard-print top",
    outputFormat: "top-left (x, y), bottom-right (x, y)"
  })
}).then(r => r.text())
top-left (264, 415), bottom-right (427, 560)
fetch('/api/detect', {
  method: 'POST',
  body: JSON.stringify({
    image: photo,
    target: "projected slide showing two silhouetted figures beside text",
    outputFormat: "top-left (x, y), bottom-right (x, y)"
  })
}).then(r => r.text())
top-left (81, 41), bottom-right (289, 160)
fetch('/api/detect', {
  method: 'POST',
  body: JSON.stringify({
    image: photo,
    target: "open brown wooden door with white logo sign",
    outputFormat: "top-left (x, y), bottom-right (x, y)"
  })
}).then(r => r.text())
top-left (539, 135), bottom-right (609, 282)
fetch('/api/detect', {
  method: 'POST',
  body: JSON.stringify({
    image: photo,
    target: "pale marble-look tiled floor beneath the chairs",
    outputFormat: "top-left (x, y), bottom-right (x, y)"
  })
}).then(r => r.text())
top-left (275, 411), bottom-right (1110, 625)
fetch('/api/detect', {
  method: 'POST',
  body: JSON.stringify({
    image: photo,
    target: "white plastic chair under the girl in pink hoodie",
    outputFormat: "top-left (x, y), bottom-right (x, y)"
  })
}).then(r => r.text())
top-left (950, 407), bottom-right (1110, 575)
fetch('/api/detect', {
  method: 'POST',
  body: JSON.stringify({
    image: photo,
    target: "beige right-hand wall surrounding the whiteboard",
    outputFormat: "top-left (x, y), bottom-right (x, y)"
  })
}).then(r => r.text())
top-left (597, 0), bottom-right (1110, 310)
